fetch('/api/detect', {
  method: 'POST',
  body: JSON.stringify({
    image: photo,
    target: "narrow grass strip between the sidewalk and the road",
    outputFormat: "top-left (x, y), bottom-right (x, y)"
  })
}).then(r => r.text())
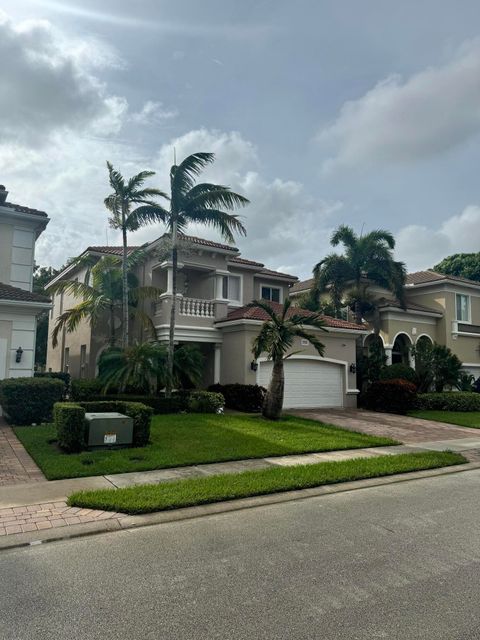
top-left (68, 451), bottom-right (465, 514)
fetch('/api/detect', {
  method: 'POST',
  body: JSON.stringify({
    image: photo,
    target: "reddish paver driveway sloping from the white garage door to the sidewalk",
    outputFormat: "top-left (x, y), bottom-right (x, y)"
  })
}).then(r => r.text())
top-left (290, 409), bottom-right (480, 444)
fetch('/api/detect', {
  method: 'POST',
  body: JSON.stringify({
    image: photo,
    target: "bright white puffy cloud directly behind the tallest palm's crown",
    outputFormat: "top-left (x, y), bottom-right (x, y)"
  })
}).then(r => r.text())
top-left (131, 129), bottom-right (342, 277)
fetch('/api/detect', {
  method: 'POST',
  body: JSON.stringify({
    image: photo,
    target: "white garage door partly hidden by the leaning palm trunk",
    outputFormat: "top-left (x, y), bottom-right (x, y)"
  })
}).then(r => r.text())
top-left (257, 358), bottom-right (345, 409)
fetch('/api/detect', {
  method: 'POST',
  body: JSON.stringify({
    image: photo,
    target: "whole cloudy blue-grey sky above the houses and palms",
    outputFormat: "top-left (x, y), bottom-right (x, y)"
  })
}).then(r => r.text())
top-left (0, 0), bottom-right (480, 277)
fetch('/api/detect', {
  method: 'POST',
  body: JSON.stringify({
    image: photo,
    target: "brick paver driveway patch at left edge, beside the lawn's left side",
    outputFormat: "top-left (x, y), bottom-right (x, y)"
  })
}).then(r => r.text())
top-left (0, 417), bottom-right (45, 487)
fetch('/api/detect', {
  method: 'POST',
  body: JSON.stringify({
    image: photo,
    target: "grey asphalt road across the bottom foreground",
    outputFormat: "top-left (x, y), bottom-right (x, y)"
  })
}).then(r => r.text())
top-left (0, 471), bottom-right (480, 640)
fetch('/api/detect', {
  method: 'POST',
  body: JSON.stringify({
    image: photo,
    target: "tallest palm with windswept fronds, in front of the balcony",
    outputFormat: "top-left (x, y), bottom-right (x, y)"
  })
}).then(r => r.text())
top-left (147, 152), bottom-right (249, 397)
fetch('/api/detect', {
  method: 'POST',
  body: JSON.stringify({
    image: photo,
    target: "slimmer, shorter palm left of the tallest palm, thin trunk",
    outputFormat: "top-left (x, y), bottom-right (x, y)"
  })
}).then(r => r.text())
top-left (104, 161), bottom-right (166, 348)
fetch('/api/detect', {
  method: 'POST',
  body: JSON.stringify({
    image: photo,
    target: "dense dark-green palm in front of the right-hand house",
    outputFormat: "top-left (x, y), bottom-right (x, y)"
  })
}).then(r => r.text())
top-left (313, 225), bottom-right (407, 324)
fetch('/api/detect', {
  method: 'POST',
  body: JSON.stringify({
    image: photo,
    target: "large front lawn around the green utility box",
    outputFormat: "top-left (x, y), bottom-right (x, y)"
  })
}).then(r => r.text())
top-left (15, 414), bottom-right (398, 480)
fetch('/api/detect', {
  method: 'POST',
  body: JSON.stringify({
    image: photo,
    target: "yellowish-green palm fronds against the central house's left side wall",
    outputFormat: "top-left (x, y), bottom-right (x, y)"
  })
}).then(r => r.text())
top-left (48, 249), bottom-right (162, 347)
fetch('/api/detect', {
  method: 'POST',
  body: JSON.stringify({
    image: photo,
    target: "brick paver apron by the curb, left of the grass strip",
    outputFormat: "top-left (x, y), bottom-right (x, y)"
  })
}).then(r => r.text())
top-left (0, 502), bottom-right (125, 536)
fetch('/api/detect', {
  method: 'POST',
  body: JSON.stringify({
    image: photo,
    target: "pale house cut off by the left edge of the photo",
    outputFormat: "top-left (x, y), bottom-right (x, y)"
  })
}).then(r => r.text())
top-left (0, 185), bottom-right (50, 379)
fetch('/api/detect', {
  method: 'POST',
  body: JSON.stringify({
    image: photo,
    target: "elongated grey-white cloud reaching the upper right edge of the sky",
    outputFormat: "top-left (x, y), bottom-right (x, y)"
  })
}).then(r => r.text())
top-left (318, 40), bottom-right (480, 171)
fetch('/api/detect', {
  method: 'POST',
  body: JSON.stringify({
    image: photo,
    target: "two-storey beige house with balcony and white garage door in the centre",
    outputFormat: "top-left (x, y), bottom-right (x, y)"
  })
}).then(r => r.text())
top-left (47, 236), bottom-right (366, 407)
